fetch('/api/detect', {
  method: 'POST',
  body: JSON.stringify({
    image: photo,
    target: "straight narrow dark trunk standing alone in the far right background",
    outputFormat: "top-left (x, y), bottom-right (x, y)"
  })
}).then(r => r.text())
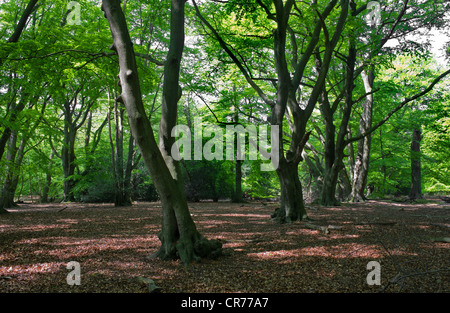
top-left (409, 128), bottom-right (423, 200)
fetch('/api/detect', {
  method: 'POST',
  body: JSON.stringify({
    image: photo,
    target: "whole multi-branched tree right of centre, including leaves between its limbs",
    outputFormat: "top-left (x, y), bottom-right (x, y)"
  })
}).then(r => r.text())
top-left (193, 0), bottom-right (349, 223)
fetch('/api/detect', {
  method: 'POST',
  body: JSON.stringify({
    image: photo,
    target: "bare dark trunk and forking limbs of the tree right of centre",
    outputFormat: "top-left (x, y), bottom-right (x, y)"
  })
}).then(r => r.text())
top-left (193, 0), bottom-right (349, 222)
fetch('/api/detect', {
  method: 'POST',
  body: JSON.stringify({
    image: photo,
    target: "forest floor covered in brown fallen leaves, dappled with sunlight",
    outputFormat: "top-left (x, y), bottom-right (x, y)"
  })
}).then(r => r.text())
top-left (0, 197), bottom-right (450, 293)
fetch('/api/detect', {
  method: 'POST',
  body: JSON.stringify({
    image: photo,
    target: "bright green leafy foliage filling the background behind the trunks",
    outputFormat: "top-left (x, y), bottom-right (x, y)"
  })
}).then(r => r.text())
top-left (0, 0), bottom-right (450, 208)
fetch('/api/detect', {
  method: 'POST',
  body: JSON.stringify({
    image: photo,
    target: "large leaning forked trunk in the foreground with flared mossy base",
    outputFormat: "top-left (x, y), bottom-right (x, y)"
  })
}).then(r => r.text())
top-left (102, 0), bottom-right (222, 265)
